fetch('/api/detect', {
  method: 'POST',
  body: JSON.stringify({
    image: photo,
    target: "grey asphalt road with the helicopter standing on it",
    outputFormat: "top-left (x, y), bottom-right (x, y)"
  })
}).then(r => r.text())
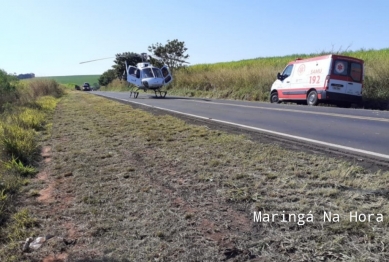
top-left (93, 91), bottom-right (389, 160)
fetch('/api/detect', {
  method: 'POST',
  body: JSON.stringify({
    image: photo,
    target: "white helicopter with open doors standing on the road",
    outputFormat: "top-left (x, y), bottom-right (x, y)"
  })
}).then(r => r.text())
top-left (80, 53), bottom-right (188, 98)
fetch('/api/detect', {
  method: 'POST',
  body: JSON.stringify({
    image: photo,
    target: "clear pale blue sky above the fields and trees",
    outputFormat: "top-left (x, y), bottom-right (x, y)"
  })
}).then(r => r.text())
top-left (0, 0), bottom-right (389, 76)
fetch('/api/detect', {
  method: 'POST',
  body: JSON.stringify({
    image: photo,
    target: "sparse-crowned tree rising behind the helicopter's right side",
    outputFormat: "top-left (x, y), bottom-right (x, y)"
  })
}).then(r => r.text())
top-left (148, 39), bottom-right (189, 71)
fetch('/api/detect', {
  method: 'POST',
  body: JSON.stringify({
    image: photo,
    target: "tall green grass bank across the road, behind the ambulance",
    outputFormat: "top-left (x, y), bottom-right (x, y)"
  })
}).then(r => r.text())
top-left (94, 49), bottom-right (389, 110)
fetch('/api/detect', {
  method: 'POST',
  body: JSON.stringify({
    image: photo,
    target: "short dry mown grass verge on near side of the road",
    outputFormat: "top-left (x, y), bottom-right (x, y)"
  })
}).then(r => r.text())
top-left (5, 92), bottom-right (389, 261)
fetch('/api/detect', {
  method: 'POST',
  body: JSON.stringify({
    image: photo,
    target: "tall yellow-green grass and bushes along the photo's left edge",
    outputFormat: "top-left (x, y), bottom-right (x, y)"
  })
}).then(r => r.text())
top-left (0, 70), bottom-right (64, 261)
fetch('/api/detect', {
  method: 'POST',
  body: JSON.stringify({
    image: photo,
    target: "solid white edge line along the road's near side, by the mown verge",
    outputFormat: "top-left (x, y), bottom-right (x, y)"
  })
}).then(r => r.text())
top-left (101, 97), bottom-right (389, 160)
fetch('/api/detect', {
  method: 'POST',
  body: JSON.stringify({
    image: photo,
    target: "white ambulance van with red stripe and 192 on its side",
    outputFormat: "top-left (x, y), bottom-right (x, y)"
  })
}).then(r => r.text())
top-left (270, 55), bottom-right (364, 107)
